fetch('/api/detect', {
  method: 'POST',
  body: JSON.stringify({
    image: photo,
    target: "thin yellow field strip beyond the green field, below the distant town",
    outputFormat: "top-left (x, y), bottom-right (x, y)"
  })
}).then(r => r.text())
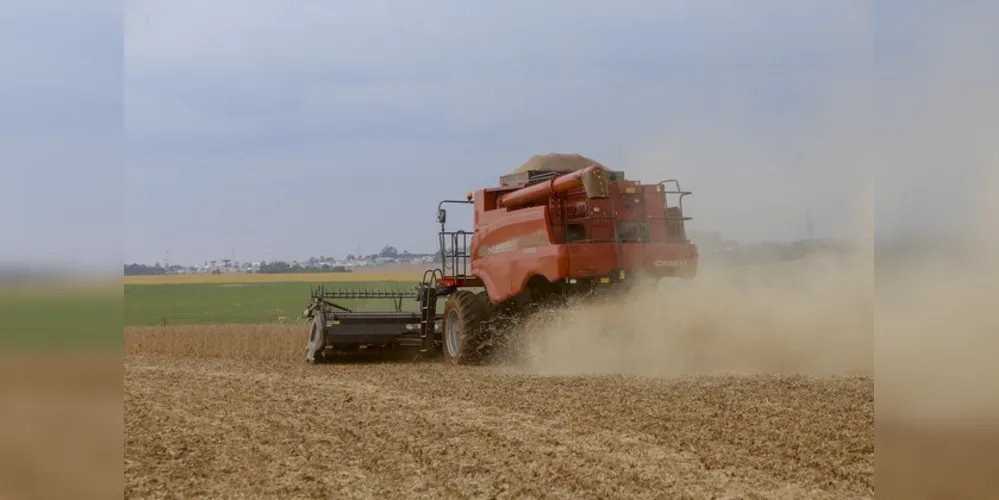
top-left (124, 271), bottom-right (423, 285)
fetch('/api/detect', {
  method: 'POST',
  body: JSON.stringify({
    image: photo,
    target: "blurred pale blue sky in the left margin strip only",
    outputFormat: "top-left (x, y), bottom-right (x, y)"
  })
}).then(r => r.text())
top-left (0, 0), bottom-right (124, 267)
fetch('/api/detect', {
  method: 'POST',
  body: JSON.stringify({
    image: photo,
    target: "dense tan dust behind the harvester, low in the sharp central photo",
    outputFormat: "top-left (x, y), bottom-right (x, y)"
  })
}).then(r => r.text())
top-left (525, 248), bottom-right (874, 376)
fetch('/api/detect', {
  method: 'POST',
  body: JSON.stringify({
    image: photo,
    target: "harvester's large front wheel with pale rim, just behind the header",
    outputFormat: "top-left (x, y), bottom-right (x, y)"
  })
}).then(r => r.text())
top-left (441, 290), bottom-right (489, 365)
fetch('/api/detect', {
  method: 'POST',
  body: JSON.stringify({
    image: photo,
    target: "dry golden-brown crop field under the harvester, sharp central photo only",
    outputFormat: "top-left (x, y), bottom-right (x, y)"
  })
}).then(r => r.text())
top-left (125, 326), bottom-right (874, 498)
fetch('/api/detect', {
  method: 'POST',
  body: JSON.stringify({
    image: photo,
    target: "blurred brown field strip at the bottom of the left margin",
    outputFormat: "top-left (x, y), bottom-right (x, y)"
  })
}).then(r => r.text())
top-left (0, 348), bottom-right (127, 499)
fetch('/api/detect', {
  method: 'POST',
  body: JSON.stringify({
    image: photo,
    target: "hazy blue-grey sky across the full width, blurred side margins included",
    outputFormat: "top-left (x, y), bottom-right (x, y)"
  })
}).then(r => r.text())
top-left (0, 0), bottom-right (999, 265)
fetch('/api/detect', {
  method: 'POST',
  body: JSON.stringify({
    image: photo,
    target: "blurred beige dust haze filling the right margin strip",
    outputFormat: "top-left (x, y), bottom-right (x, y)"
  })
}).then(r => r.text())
top-left (875, 2), bottom-right (999, 426)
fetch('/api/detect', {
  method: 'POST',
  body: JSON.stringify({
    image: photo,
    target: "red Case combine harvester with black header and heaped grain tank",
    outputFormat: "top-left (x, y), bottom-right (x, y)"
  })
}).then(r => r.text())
top-left (305, 157), bottom-right (698, 364)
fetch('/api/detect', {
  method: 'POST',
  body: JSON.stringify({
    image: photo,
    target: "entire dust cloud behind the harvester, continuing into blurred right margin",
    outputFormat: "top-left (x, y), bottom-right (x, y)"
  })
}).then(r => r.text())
top-left (512, 1), bottom-right (999, 428)
